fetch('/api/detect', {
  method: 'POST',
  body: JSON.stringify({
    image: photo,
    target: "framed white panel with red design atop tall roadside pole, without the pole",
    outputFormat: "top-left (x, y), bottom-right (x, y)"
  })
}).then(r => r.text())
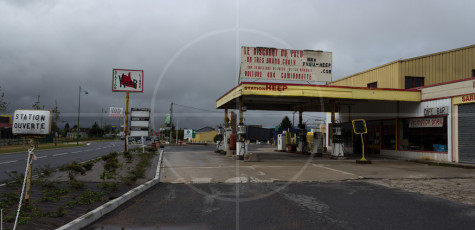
top-left (112, 69), bottom-right (143, 93)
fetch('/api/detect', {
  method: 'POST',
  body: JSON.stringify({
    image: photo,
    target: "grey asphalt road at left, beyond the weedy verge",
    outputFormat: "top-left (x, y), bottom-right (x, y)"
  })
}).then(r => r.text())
top-left (0, 141), bottom-right (124, 184)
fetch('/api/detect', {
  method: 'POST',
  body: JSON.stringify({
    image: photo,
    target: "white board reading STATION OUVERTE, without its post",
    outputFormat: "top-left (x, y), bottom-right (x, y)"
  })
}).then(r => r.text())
top-left (12, 109), bottom-right (51, 135)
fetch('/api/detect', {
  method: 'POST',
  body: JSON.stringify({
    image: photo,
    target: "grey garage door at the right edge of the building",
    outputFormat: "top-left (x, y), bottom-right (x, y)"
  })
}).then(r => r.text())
top-left (458, 104), bottom-right (475, 164)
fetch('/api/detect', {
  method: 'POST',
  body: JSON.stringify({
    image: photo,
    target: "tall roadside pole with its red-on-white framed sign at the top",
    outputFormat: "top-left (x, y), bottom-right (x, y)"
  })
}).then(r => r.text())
top-left (112, 69), bottom-right (143, 151)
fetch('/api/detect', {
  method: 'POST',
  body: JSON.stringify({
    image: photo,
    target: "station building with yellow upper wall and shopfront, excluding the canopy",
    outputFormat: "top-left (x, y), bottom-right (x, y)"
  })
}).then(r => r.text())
top-left (327, 45), bottom-right (475, 163)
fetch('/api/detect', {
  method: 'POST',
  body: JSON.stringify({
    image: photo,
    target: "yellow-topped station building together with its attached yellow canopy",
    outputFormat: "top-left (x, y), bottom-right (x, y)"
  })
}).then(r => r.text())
top-left (216, 45), bottom-right (475, 164)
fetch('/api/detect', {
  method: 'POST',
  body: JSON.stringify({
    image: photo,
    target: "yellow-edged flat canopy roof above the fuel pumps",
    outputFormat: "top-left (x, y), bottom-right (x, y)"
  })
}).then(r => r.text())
top-left (216, 82), bottom-right (421, 112)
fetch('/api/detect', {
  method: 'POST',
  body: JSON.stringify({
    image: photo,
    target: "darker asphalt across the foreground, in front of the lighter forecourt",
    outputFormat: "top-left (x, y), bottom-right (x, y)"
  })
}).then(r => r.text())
top-left (86, 182), bottom-right (475, 230)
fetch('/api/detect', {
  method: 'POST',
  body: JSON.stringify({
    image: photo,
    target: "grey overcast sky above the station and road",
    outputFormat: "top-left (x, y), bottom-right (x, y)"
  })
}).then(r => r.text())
top-left (0, 0), bottom-right (475, 129)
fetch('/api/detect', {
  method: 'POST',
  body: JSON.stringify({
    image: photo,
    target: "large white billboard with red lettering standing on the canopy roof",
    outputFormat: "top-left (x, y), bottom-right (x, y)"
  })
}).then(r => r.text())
top-left (239, 46), bottom-right (332, 82)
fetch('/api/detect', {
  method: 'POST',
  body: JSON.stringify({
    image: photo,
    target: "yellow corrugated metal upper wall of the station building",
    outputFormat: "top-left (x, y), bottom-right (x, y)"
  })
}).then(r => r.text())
top-left (332, 45), bottom-right (475, 89)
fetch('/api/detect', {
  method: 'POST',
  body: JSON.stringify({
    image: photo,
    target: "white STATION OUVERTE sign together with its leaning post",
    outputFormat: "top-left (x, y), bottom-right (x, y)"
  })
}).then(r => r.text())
top-left (12, 109), bottom-right (52, 229)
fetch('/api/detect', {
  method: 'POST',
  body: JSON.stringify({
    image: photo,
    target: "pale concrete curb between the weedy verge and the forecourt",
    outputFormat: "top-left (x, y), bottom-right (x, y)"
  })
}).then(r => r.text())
top-left (56, 149), bottom-right (163, 230)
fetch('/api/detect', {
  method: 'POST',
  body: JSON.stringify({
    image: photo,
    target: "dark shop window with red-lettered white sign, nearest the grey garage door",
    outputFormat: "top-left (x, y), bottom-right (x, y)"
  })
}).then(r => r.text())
top-left (399, 117), bottom-right (447, 152)
